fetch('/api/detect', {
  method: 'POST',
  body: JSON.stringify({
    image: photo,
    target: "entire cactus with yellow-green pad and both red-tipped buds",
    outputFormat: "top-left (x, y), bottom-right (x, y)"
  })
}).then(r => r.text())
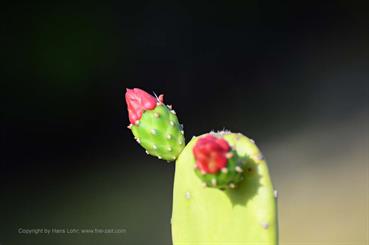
top-left (126, 89), bottom-right (278, 245)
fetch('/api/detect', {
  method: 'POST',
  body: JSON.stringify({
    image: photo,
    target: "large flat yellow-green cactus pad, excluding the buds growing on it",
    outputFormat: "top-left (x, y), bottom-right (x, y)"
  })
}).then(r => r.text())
top-left (171, 132), bottom-right (278, 245)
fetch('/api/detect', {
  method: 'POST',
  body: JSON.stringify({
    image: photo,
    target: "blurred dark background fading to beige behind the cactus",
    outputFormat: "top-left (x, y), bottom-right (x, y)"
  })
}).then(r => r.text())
top-left (0, 0), bottom-right (369, 245)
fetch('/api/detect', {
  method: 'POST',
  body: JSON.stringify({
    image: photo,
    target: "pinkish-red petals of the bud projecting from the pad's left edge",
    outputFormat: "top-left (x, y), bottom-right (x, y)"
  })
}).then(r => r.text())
top-left (126, 88), bottom-right (157, 124)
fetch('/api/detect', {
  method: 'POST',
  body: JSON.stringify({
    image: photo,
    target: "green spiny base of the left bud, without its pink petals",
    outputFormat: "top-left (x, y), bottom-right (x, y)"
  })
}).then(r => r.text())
top-left (131, 104), bottom-right (185, 161)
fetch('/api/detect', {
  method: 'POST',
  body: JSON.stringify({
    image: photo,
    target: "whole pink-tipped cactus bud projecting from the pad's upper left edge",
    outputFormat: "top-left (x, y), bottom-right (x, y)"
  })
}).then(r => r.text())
top-left (125, 88), bottom-right (184, 161)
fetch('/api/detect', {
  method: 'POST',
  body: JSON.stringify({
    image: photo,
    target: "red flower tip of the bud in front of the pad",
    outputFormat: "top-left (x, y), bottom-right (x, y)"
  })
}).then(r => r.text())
top-left (193, 135), bottom-right (230, 174)
